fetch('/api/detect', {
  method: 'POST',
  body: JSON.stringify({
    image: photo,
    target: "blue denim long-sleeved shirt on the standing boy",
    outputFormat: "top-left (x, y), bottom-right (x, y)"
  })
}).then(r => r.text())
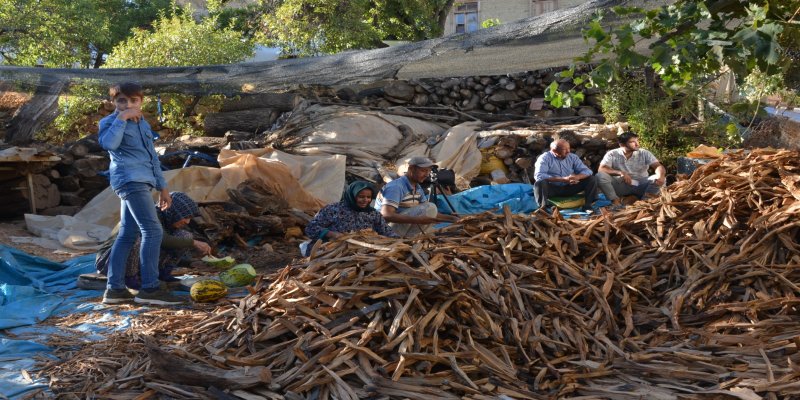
top-left (98, 111), bottom-right (167, 190)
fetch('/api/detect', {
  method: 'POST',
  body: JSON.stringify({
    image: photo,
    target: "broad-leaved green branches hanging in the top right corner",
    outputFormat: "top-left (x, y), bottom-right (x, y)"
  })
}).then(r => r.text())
top-left (556, 0), bottom-right (800, 109)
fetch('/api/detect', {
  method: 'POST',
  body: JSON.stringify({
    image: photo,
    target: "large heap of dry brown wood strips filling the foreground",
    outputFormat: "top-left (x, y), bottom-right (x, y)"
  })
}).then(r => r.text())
top-left (40, 150), bottom-right (800, 399)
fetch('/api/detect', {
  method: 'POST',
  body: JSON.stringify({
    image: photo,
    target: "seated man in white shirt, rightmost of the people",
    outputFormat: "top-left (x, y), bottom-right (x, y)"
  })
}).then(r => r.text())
top-left (597, 131), bottom-right (667, 209)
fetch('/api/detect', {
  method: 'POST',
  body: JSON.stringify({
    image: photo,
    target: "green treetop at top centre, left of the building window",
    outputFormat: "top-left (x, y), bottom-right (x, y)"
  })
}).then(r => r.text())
top-left (260, 0), bottom-right (453, 55)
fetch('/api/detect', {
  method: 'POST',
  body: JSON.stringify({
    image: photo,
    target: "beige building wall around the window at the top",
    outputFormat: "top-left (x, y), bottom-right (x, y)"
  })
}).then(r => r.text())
top-left (444, 0), bottom-right (588, 35)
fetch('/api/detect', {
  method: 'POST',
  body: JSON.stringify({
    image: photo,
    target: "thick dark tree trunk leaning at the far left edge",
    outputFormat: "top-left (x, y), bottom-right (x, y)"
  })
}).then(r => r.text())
top-left (6, 77), bottom-right (67, 145)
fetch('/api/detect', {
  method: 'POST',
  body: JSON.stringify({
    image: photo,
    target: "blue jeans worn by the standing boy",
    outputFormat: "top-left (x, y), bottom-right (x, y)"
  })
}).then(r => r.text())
top-left (108, 182), bottom-right (164, 289)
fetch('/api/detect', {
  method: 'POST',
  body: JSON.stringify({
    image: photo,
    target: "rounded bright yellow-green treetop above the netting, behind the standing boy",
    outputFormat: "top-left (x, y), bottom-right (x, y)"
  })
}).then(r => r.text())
top-left (106, 13), bottom-right (254, 68)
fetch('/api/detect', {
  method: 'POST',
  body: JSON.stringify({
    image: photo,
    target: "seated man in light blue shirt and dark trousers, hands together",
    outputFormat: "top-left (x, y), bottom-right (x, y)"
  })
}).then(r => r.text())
top-left (533, 139), bottom-right (597, 210)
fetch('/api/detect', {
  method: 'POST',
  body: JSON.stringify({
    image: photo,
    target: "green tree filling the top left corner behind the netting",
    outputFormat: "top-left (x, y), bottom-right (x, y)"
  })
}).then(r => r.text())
top-left (0, 0), bottom-right (172, 68)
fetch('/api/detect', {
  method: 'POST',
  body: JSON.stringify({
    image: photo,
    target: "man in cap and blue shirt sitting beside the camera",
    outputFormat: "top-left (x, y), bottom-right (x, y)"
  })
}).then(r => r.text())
top-left (375, 156), bottom-right (458, 237)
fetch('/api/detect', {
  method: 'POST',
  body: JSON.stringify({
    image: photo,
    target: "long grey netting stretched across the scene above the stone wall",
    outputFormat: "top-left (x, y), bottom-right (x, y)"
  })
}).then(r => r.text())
top-left (0, 0), bottom-right (674, 94)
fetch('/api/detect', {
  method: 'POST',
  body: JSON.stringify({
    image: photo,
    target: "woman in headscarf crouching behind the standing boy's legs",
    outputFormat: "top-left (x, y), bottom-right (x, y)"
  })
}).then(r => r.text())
top-left (95, 192), bottom-right (211, 289)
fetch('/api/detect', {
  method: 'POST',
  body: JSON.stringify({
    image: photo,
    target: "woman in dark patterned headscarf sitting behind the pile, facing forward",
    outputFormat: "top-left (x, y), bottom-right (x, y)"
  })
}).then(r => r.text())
top-left (304, 181), bottom-right (398, 255)
